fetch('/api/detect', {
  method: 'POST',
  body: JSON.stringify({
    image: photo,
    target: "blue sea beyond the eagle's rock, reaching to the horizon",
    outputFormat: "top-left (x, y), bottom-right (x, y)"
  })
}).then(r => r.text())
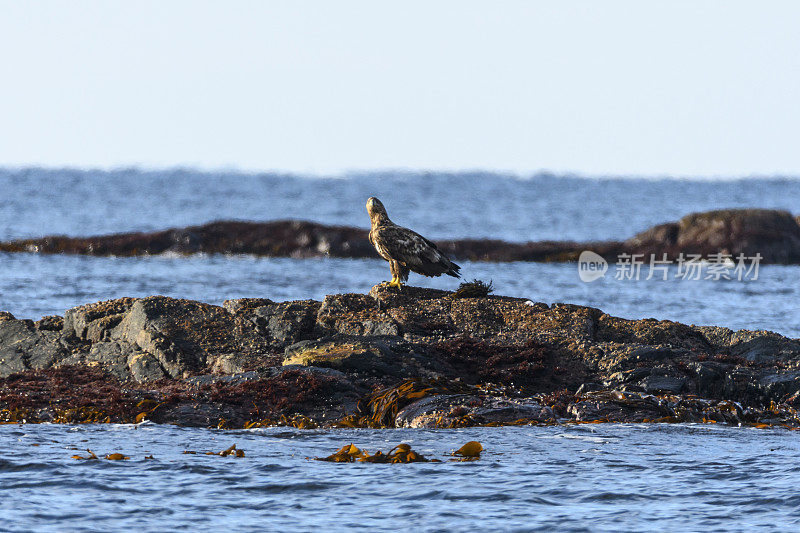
top-left (0, 169), bottom-right (800, 337)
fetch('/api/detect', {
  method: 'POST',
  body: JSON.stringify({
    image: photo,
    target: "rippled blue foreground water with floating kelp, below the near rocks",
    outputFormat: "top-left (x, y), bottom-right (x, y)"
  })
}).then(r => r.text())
top-left (0, 423), bottom-right (800, 533)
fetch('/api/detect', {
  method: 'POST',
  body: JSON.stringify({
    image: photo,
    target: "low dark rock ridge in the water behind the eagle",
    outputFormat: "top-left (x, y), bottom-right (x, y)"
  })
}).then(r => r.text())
top-left (0, 209), bottom-right (800, 264)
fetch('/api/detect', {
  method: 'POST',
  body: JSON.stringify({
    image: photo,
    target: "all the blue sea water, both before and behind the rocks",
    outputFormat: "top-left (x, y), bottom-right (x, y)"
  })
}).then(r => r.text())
top-left (0, 169), bottom-right (800, 532)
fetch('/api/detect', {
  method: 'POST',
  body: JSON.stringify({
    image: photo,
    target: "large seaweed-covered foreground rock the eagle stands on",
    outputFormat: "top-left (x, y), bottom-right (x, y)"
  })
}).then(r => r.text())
top-left (0, 286), bottom-right (800, 427)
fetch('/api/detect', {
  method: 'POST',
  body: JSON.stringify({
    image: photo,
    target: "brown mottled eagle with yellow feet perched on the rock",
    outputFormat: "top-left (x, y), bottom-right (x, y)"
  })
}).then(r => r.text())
top-left (367, 196), bottom-right (461, 289)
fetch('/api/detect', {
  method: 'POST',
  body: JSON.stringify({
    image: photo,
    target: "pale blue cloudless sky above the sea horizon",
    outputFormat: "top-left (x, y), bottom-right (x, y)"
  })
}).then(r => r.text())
top-left (0, 0), bottom-right (800, 177)
